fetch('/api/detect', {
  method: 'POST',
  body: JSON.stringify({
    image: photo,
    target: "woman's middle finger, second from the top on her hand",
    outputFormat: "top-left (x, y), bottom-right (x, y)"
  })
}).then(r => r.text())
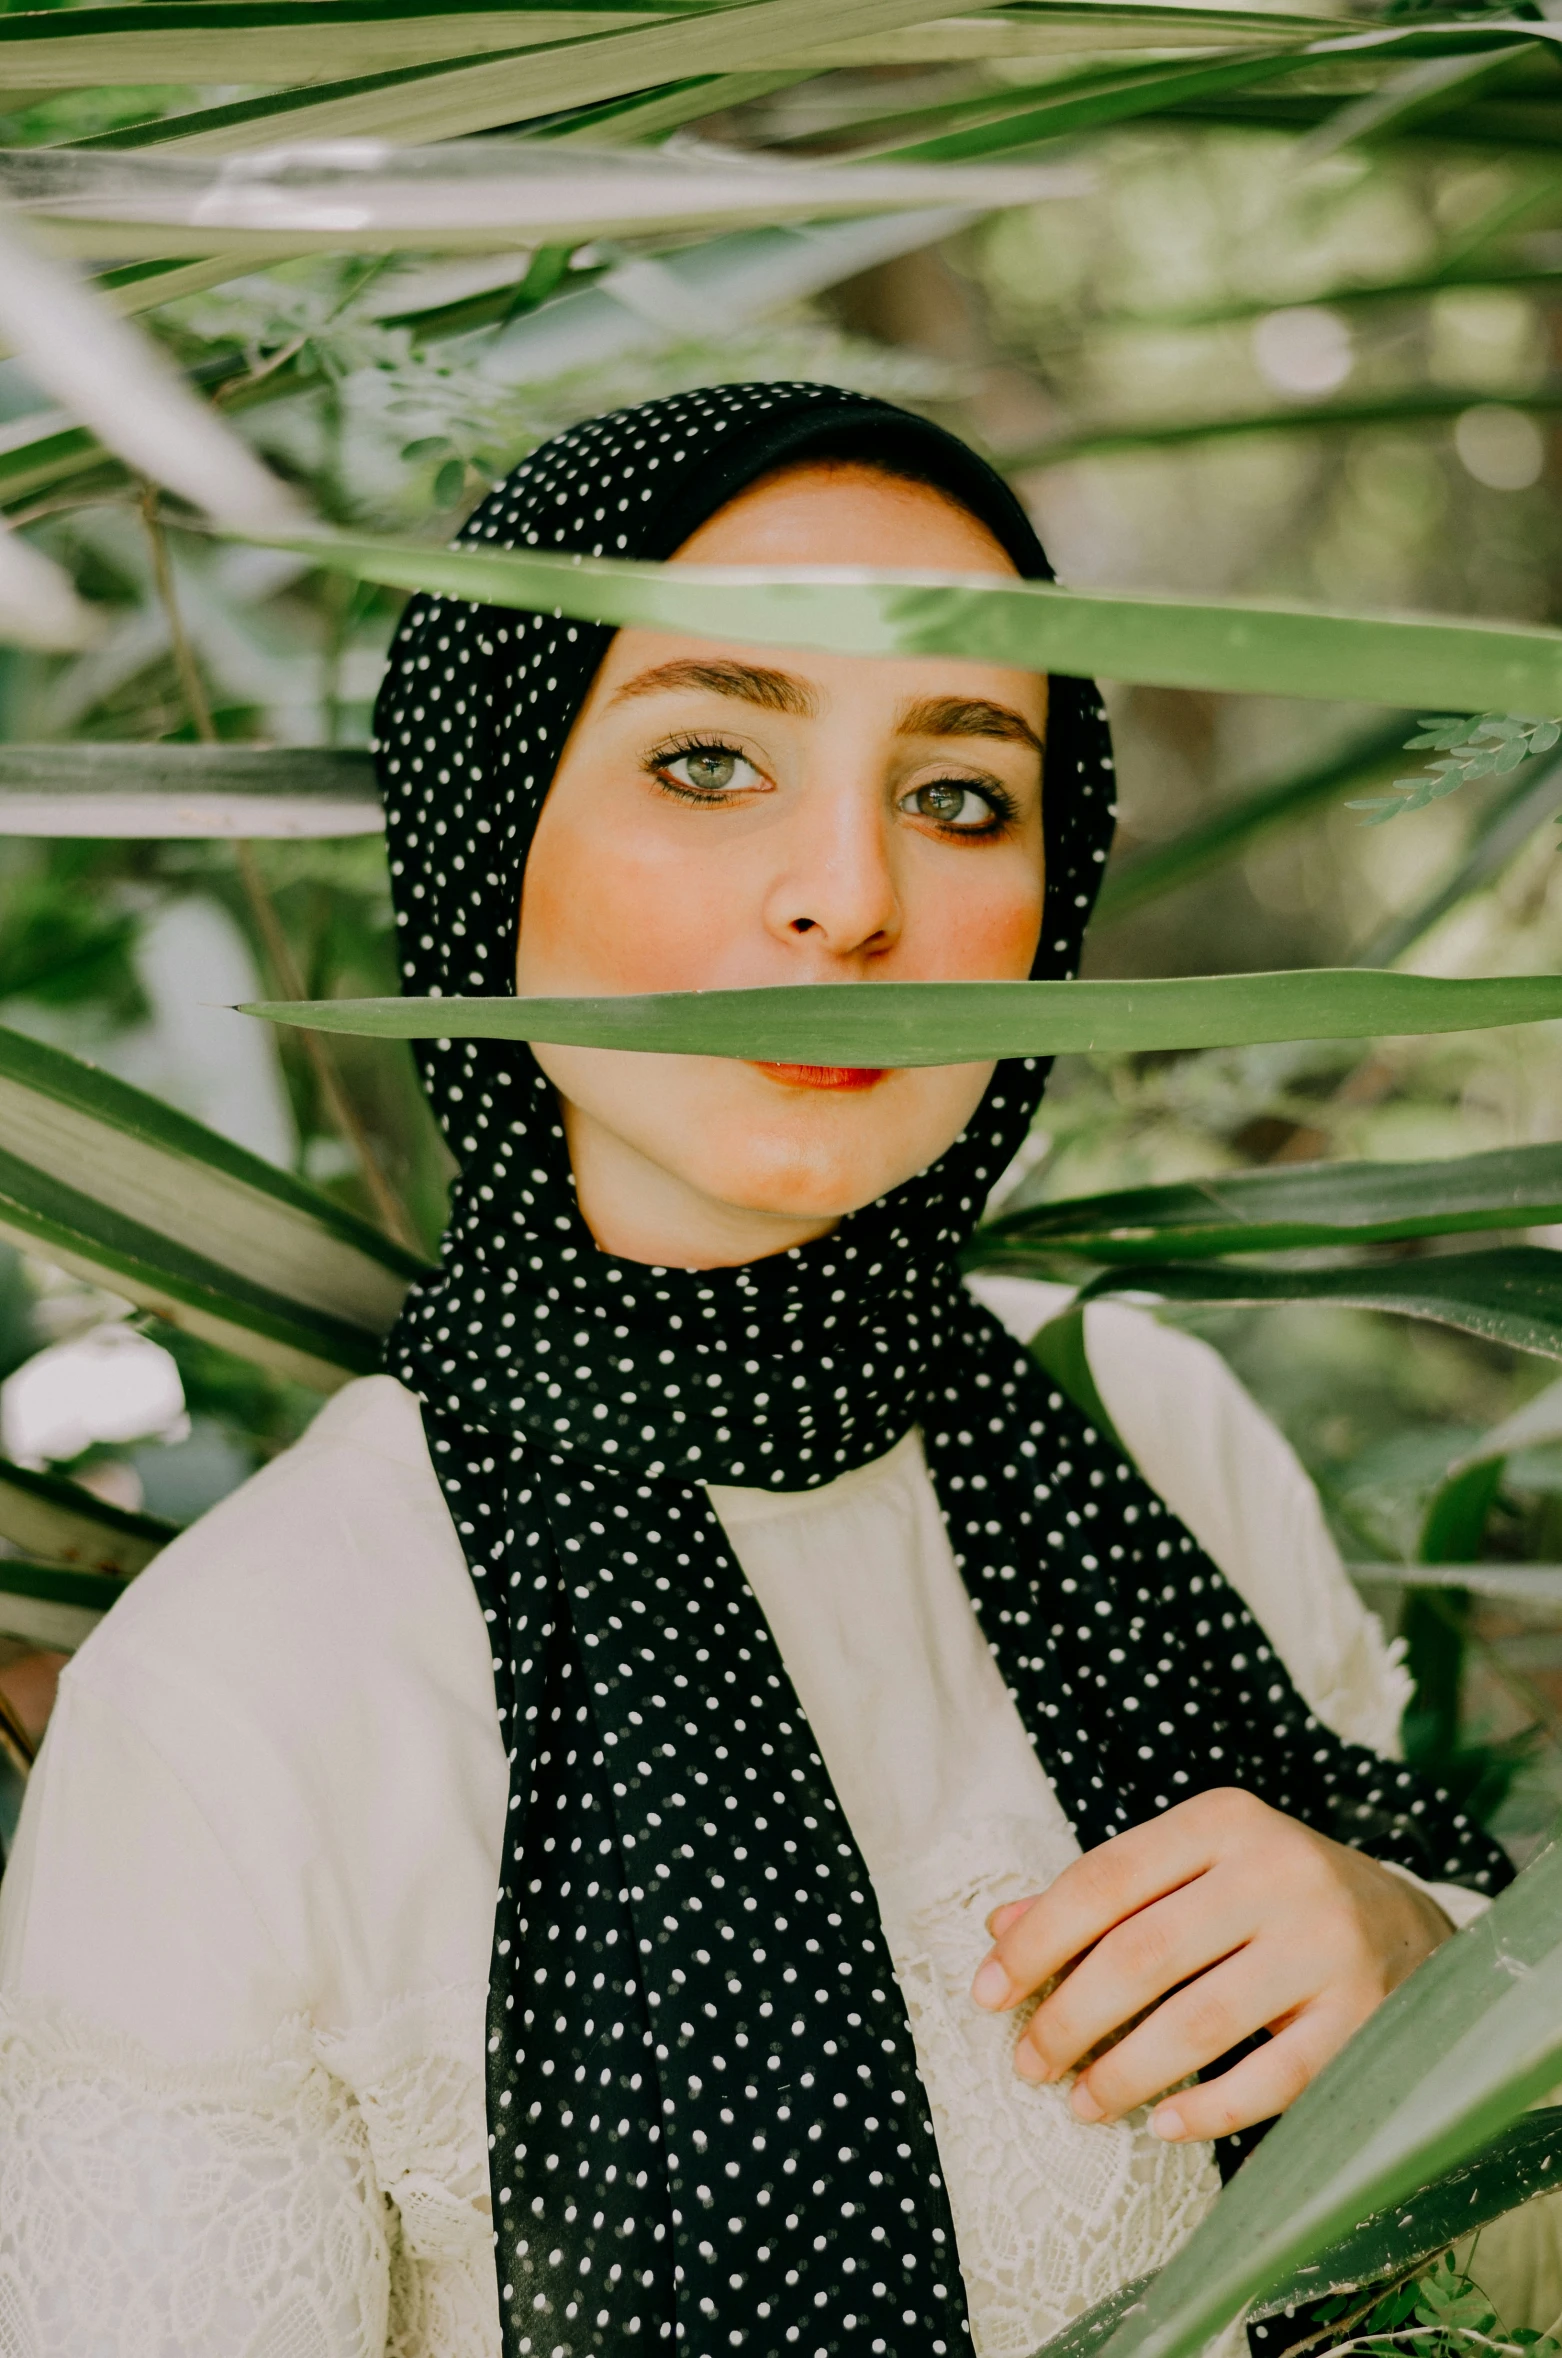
top-left (1022, 1868), bottom-right (1264, 2103)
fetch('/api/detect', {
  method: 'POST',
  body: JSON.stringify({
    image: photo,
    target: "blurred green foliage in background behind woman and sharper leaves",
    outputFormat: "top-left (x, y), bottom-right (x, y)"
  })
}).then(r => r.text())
top-left (0, 9), bottom-right (1562, 1853)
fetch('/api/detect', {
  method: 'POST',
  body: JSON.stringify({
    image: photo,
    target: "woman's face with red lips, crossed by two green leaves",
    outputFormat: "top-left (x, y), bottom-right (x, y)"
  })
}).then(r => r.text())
top-left (517, 465), bottom-right (1048, 1269)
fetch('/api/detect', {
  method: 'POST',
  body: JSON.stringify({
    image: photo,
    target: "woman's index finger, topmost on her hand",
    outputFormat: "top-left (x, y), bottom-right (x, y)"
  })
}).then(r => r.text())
top-left (972, 1787), bottom-right (1279, 2009)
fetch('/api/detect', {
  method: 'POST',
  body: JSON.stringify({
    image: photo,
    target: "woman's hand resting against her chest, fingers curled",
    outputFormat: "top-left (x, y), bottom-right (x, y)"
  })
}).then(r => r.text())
top-left (972, 1787), bottom-right (1453, 2139)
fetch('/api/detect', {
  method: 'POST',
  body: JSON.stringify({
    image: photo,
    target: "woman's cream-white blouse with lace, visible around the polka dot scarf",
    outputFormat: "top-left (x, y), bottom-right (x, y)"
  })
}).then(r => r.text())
top-left (0, 1280), bottom-right (1482, 2358)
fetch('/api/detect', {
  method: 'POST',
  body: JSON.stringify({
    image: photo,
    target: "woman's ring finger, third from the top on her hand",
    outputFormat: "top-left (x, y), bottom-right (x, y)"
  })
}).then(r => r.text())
top-left (1052, 1941), bottom-right (1319, 2120)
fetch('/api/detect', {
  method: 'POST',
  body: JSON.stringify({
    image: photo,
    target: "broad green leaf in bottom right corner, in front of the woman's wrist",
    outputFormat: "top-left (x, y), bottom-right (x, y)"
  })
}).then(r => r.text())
top-left (1104, 1849), bottom-right (1562, 2358)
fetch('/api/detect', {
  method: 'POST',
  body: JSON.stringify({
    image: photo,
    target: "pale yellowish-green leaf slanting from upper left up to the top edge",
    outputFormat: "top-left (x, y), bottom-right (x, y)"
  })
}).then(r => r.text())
top-left (67, 0), bottom-right (986, 156)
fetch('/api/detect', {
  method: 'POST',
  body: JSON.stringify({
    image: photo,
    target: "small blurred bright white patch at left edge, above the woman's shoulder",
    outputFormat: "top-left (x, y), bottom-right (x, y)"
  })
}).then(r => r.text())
top-left (0, 1323), bottom-right (189, 1467)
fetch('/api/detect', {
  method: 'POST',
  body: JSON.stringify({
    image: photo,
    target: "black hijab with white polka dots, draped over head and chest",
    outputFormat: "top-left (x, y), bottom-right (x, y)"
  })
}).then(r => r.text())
top-left (378, 384), bottom-right (1501, 2358)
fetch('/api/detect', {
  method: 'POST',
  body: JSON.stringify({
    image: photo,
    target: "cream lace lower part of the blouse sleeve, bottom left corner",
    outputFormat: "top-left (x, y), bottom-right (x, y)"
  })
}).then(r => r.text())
top-left (0, 1990), bottom-right (498, 2358)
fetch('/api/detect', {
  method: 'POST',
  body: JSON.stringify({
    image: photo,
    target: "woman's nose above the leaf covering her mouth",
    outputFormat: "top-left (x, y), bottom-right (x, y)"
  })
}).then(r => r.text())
top-left (764, 785), bottom-right (904, 964)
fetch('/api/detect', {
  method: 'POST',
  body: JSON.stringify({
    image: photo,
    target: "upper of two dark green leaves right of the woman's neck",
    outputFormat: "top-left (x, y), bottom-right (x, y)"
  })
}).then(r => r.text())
top-left (972, 1146), bottom-right (1562, 1269)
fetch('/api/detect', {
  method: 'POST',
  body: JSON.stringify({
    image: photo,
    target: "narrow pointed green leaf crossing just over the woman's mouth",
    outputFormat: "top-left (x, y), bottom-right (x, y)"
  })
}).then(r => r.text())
top-left (243, 967), bottom-right (1562, 1068)
